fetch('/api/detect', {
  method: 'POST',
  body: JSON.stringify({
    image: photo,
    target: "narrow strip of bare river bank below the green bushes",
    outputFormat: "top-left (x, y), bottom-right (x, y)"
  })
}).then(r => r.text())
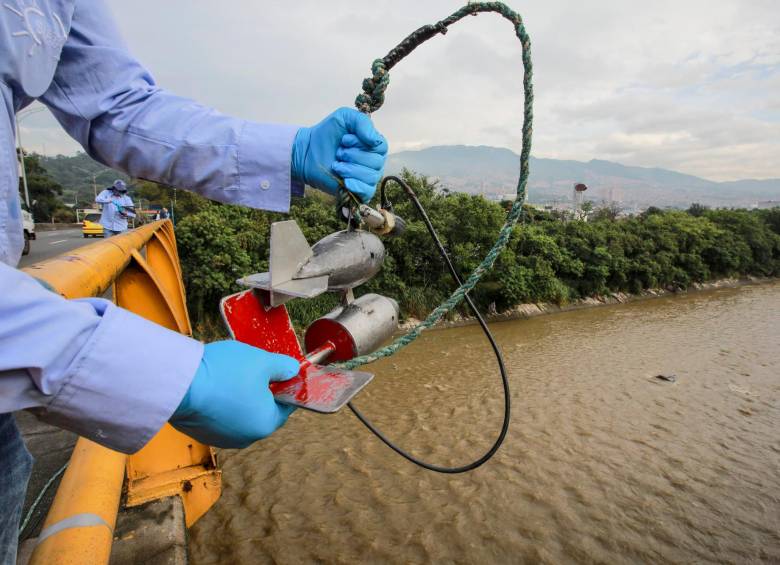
top-left (399, 276), bottom-right (779, 331)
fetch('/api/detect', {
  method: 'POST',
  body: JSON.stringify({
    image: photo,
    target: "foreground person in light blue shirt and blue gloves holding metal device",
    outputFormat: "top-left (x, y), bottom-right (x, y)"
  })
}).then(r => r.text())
top-left (0, 0), bottom-right (387, 564)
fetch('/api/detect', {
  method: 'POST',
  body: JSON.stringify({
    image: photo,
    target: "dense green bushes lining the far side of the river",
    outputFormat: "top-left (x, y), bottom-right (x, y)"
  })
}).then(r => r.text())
top-left (176, 172), bottom-right (780, 332)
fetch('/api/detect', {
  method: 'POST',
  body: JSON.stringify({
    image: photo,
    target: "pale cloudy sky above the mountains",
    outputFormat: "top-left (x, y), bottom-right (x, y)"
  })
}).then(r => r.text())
top-left (21, 0), bottom-right (780, 180)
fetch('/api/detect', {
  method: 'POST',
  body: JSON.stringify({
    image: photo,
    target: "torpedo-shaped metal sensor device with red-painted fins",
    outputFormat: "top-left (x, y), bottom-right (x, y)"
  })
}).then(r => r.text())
top-left (220, 219), bottom-right (399, 413)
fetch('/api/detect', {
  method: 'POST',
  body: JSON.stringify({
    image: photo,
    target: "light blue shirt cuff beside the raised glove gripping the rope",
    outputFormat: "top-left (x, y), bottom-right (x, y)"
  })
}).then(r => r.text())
top-left (238, 122), bottom-right (303, 213)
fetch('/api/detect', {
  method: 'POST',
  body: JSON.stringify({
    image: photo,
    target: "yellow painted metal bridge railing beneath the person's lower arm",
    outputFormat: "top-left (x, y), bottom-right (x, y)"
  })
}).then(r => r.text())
top-left (23, 220), bottom-right (222, 564)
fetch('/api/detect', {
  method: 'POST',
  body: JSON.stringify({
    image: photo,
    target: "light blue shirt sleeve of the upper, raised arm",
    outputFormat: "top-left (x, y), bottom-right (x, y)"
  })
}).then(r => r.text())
top-left (41, 0), bottom-right (302, 212)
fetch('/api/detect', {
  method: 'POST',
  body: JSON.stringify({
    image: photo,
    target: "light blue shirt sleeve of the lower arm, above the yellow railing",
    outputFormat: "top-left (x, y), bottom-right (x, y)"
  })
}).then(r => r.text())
top-left (0, 263), bottom-right (203, 453)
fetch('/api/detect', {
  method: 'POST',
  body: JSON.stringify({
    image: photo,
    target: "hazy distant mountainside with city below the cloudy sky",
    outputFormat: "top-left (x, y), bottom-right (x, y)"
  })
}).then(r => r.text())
top-left (386, 145), bottom-right (780, 206)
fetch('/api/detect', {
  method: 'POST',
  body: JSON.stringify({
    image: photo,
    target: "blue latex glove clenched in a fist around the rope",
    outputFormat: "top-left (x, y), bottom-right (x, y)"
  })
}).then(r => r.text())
top-left (292, 108), bottom-right (387, 202)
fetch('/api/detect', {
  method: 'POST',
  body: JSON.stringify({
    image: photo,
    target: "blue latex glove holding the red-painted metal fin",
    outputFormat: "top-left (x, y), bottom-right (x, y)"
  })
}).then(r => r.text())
top-left (170, 341), bottom-right (299, 448)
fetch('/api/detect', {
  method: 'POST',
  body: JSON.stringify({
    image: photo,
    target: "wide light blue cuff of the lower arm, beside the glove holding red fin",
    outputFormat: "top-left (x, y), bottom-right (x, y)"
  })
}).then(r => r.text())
top-left (39, 299), bottom-right (203, 453)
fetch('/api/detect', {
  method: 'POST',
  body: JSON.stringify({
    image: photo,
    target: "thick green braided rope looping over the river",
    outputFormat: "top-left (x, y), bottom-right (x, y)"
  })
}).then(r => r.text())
top-left (339, 2), bottom-right (534, 369)
